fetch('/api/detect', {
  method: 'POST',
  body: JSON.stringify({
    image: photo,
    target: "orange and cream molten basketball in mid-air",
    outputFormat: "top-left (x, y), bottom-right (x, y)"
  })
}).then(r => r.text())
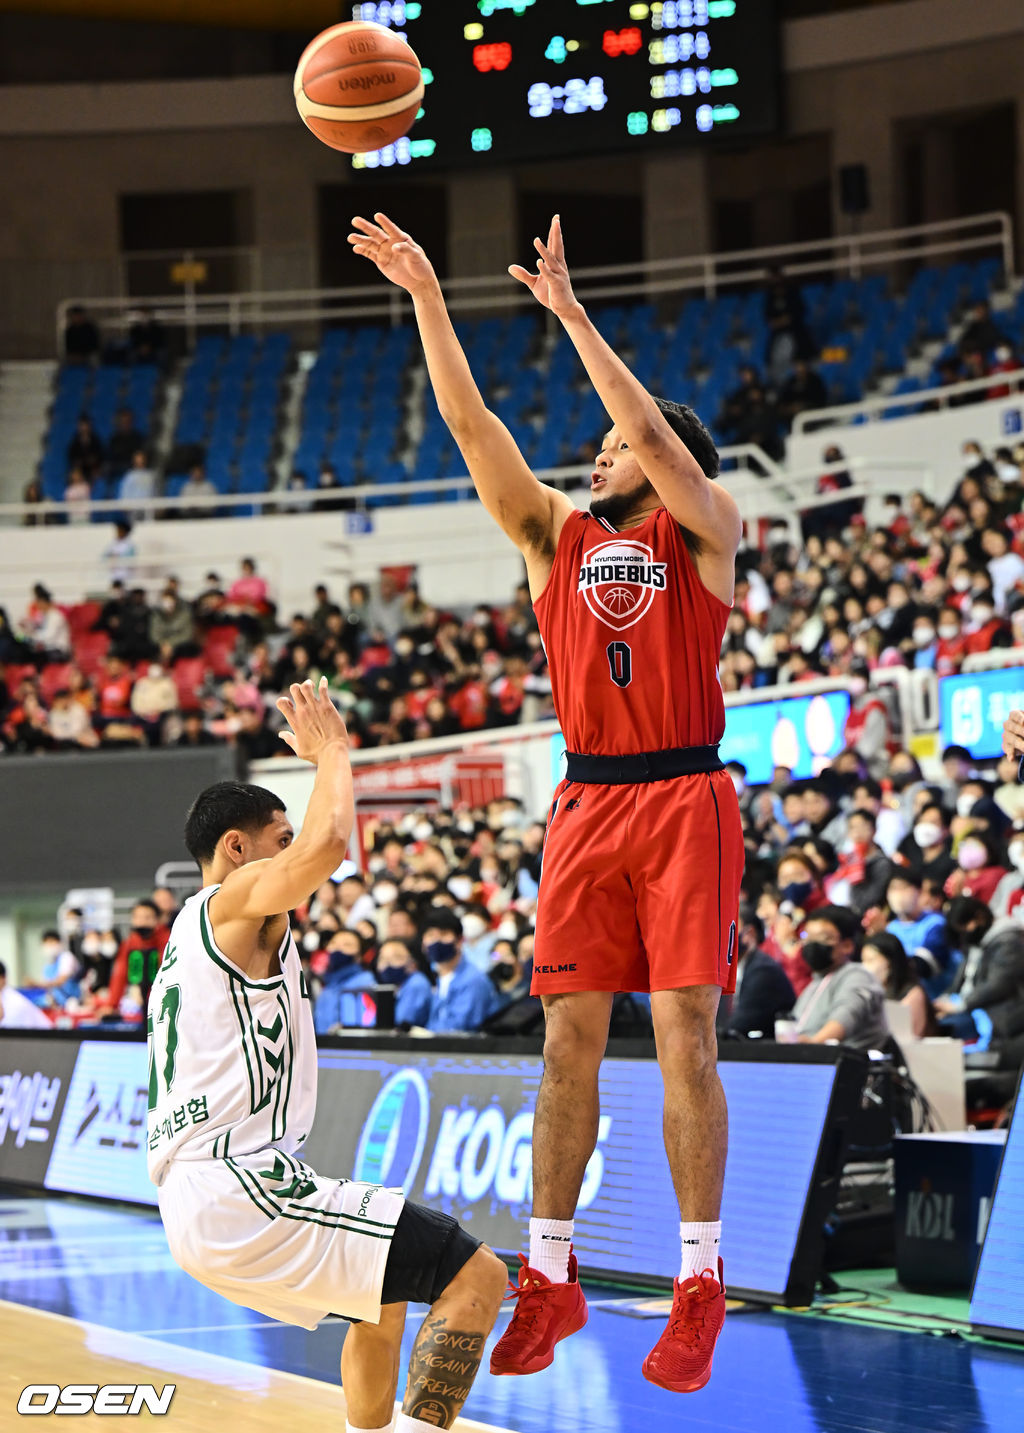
top-left (294, 20), bottom-right (422, 155)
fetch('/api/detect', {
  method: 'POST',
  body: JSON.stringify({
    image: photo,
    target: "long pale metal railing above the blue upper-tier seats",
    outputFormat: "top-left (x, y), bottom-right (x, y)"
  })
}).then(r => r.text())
top-left (56, 212), bottom-right (1014, 351)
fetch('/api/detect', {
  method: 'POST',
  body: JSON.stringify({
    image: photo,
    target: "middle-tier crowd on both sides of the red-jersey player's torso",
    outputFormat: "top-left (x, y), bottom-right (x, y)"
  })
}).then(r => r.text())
top-left (10, 429), bottom-right (1024, 770)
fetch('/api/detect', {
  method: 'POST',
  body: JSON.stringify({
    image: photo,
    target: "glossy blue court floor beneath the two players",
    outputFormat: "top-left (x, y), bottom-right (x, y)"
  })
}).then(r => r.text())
top-left (0, 1197), bottom-right (1024, 1433)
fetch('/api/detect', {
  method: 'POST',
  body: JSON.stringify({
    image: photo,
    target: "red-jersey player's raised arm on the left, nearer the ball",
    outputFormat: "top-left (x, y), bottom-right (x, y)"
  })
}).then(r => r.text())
top-left (348, 214), bottom-right (573, 552)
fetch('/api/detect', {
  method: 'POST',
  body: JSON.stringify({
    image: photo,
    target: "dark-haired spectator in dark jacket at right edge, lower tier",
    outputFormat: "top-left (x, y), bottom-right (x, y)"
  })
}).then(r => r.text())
top-left (935, 897), bottom-right (1024, 1050)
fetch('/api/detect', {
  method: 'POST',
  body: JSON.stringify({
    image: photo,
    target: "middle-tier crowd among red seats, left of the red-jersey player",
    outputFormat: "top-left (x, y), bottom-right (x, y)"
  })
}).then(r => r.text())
top-left (0, 561), bottom-right (551, 761)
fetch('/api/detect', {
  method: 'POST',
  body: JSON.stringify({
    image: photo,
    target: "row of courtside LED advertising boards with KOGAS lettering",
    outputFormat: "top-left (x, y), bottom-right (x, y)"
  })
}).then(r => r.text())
top-left (0, 1039), bottom-right (838, 1298)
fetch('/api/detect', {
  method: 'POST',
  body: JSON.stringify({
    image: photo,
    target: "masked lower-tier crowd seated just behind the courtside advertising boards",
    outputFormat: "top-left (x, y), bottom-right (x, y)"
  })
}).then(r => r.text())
top-left (8, 748), bottom-right (1024, 1100)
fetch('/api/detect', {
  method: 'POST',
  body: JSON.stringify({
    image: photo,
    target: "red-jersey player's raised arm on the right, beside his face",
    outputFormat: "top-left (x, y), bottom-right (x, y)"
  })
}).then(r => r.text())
top-left (508, 214), bottom-right (742, 563)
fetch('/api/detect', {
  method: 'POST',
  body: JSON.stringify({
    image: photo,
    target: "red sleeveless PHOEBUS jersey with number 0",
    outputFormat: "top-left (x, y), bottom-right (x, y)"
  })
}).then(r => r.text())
top-left (534, 507), bottom-right (730, 757)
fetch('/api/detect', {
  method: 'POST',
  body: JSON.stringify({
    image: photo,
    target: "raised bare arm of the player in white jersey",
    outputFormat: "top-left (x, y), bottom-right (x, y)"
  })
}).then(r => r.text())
top-left (211, 678), bottom-right (355, 944)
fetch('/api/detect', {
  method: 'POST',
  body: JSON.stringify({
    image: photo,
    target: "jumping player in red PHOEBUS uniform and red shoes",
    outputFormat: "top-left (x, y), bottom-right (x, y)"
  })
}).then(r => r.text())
top-left (349, 214), bottom-right (743, 1391)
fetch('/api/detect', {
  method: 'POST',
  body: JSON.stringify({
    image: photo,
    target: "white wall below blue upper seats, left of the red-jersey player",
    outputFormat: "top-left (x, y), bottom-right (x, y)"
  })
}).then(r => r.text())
top-left (0, 499), bottom-right (535, 619)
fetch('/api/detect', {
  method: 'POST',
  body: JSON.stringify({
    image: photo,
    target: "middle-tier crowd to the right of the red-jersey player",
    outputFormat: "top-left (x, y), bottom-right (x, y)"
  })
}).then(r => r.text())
top-left (722, 443), bottom-right (1024, 705)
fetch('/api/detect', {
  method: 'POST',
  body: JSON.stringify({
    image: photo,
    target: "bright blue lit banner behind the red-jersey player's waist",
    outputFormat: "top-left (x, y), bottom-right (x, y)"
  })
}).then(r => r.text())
top-left (551, 692), bottom-right (849, 787)
